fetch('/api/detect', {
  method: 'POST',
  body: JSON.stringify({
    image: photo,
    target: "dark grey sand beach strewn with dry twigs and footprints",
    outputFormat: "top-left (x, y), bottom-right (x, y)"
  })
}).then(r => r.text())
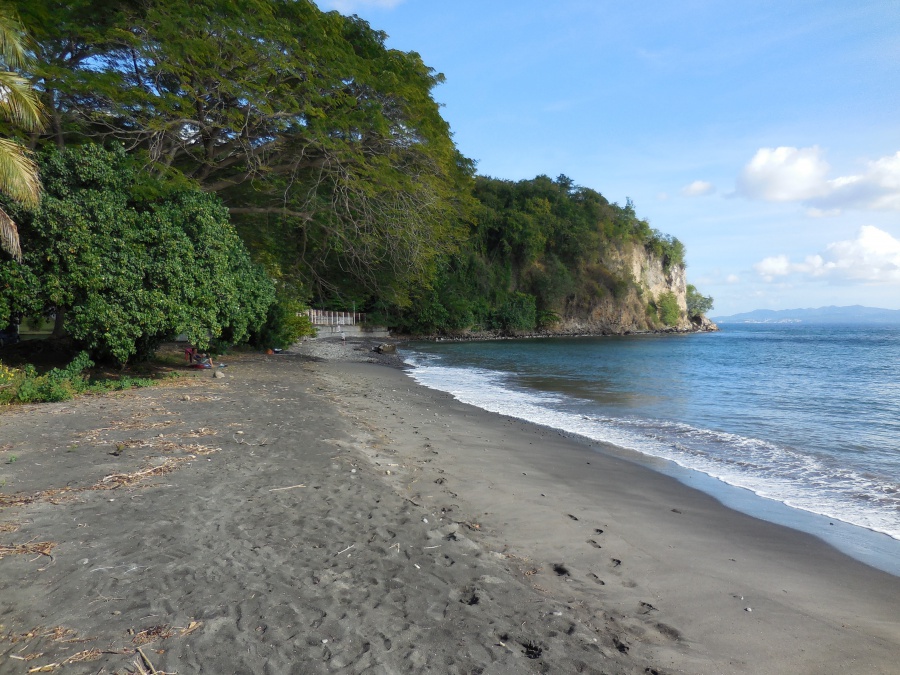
top-left (0, 342), bottom-right (900, 675)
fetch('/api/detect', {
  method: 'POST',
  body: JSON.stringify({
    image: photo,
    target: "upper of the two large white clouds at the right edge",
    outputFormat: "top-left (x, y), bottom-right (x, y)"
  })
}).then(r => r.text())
top-left (737, 146), bottom-right (900, 211)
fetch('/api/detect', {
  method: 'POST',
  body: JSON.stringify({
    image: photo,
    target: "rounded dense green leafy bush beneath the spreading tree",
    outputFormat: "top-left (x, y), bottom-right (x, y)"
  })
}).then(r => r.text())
top-left (0, 145), bottom-right (274, 363)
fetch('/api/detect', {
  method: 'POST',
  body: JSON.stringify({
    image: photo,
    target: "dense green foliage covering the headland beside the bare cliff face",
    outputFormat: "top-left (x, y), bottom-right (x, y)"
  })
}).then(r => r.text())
top-left (388, 176), bottom-right (684, 333)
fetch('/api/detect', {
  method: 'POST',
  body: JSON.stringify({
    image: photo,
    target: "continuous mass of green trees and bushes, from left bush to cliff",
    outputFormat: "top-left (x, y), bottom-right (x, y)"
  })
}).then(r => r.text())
top-left (0, 0), bottom-right (716, 363)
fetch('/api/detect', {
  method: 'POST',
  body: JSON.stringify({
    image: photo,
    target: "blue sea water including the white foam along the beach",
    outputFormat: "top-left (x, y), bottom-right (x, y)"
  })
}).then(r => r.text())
top-left (405, 324), bottom-right (900, 572)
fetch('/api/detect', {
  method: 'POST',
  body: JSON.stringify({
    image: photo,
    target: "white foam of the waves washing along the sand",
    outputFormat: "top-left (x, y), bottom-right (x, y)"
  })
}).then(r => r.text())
top-left (407, 354), bottom-right (900, 540)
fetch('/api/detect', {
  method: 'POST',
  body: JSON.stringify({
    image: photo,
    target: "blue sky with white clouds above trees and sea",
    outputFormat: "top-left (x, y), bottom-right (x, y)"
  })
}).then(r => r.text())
top-left (319, 0), bottom-right (900, 315)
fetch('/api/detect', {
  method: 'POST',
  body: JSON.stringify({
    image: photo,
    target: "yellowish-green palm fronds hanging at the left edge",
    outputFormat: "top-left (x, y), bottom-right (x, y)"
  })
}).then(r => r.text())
top-left (0, 5), bottom-right (42, 260)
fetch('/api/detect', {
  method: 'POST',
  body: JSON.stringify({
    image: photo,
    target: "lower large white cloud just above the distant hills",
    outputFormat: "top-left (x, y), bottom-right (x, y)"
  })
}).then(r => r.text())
top-left (753, 225), bottom-right (900, 283)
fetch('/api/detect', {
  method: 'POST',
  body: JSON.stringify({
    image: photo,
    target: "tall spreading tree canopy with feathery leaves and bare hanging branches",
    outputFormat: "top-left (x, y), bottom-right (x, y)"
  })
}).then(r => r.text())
top-left (18, 0), bottom-right (472, 304)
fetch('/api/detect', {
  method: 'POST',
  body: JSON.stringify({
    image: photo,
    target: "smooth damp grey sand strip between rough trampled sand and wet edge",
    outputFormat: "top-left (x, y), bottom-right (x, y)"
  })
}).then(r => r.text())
top-left (320, 356), bottom-right (900, 673)
